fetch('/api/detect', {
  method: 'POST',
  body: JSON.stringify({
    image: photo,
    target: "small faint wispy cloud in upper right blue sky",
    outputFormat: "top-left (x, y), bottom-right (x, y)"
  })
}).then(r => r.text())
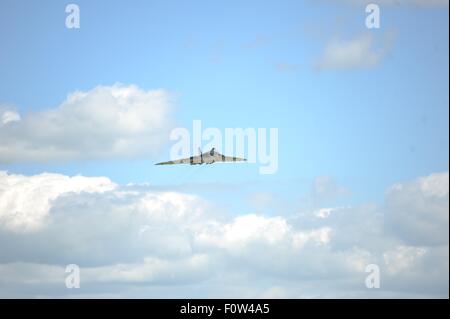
top-left (316, 33), bottom-right (393, 70)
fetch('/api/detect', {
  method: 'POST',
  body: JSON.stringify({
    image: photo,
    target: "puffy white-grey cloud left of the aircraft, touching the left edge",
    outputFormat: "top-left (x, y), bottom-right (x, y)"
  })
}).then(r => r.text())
top-left (0, 84), bottom-right (171, 163)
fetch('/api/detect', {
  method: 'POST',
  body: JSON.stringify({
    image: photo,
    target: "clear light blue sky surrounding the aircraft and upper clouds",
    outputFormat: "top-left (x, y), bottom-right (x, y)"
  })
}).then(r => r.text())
top-left (0, 0), bottom-right (449, 300)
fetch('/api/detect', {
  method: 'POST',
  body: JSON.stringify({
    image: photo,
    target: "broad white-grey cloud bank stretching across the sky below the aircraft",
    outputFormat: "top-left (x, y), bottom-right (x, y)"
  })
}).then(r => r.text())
top-left (0, 172), bottom-right (448, 297)
